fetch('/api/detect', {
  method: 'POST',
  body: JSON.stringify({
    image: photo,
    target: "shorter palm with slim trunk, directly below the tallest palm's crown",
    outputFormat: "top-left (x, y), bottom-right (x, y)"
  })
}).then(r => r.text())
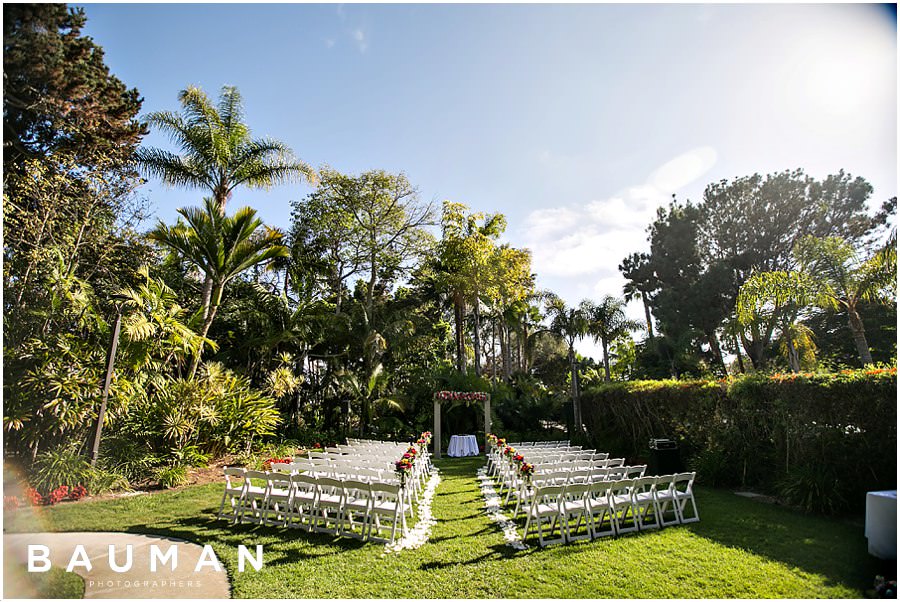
top-left (148, 198), bottom-right (288, 377)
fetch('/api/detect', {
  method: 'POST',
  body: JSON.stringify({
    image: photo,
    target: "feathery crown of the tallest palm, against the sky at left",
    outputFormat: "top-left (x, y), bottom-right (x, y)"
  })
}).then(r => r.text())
top-left (137, 86), bottom-right (317, 216)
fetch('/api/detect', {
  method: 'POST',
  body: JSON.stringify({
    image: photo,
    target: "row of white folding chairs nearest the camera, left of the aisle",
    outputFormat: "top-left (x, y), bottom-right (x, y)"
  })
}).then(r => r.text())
top-left (219, 468), bottom-right (412, 541)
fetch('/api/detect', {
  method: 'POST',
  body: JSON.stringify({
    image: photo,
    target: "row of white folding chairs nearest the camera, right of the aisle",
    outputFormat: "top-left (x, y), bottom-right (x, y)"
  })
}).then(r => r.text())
top-left (523, 473), bottom-right (700, 546)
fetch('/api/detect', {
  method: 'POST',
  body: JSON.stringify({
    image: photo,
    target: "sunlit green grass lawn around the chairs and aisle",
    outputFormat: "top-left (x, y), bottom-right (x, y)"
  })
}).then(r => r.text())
top-left (6, 458), bottom-right (878, 598)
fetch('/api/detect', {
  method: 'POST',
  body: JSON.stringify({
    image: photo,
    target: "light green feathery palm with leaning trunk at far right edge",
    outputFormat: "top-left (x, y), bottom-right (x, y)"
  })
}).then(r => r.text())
top-left (795, 236), bottom-right (897, 365)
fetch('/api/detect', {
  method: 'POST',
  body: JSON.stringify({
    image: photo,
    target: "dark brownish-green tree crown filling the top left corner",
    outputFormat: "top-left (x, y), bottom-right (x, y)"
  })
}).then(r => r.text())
top-left (3, 4), bottom-right (144, 171)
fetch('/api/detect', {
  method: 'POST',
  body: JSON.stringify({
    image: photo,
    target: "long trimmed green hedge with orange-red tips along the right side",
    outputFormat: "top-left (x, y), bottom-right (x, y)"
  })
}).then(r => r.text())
top-left (582, 368), bottom-right (897, 513)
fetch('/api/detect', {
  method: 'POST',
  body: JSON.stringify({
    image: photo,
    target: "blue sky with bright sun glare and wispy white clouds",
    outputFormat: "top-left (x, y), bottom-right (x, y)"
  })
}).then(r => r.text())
top-left (84, 4), bottom-right (897, 355)
